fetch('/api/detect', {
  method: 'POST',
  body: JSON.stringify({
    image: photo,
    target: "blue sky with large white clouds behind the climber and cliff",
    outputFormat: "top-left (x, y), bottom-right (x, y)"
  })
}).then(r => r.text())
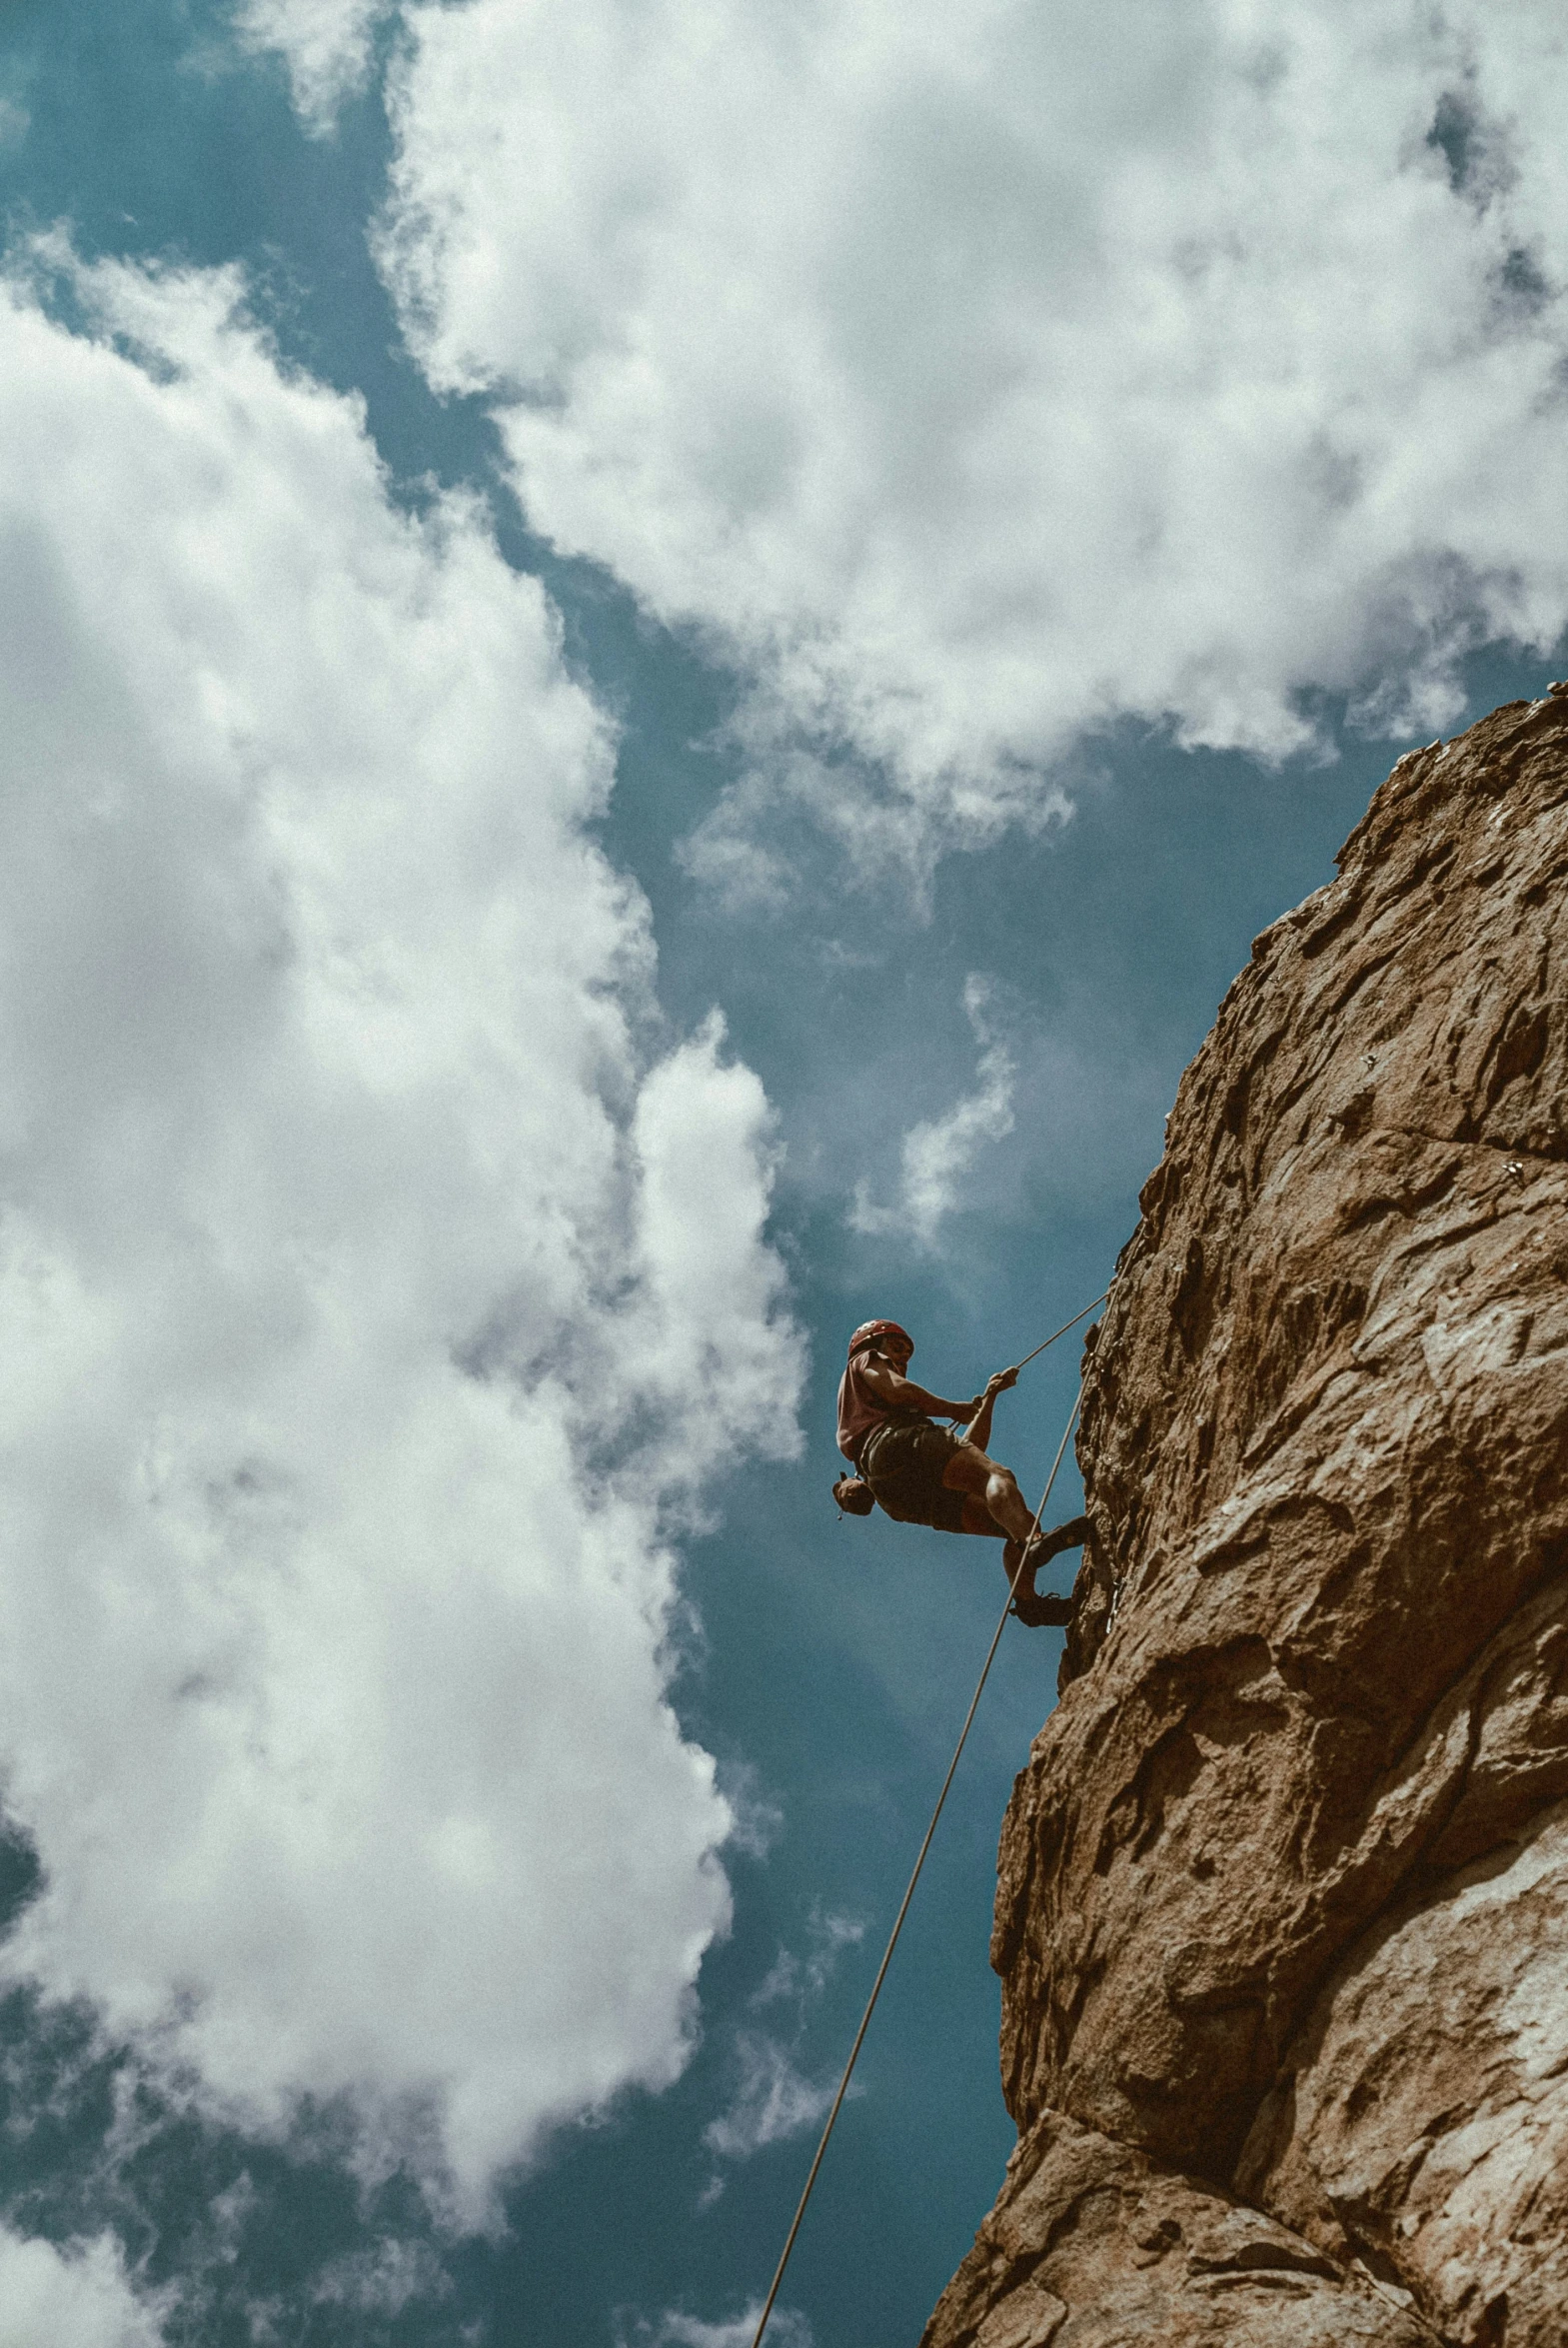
top-left (0, 0), bottom-right (1568, 2348)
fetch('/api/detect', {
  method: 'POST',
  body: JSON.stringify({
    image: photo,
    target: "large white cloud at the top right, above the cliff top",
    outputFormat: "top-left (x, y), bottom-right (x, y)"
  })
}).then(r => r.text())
top-left (361, 0), bottom-right (1568, 869)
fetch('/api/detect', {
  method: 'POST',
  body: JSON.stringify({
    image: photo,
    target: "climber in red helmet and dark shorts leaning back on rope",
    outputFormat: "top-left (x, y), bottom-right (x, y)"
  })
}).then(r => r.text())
top-left (833, 1321), bottom-right (1089, 1627)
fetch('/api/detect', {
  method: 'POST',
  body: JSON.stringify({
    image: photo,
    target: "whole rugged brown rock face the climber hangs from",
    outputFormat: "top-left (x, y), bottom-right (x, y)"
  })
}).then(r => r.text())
top-left (927, 688), bottom-right (1568, 2348)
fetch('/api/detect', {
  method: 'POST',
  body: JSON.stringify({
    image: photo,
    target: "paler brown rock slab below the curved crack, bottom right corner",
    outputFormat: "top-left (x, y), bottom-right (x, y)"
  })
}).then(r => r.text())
top-left (1239, 1803), bottom-right (1568, 2348)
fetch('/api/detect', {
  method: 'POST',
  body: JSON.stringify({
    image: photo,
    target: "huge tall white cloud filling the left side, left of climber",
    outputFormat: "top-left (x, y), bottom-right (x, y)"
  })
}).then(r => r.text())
top-left (0, 254), bottom-right (798, 2219)
